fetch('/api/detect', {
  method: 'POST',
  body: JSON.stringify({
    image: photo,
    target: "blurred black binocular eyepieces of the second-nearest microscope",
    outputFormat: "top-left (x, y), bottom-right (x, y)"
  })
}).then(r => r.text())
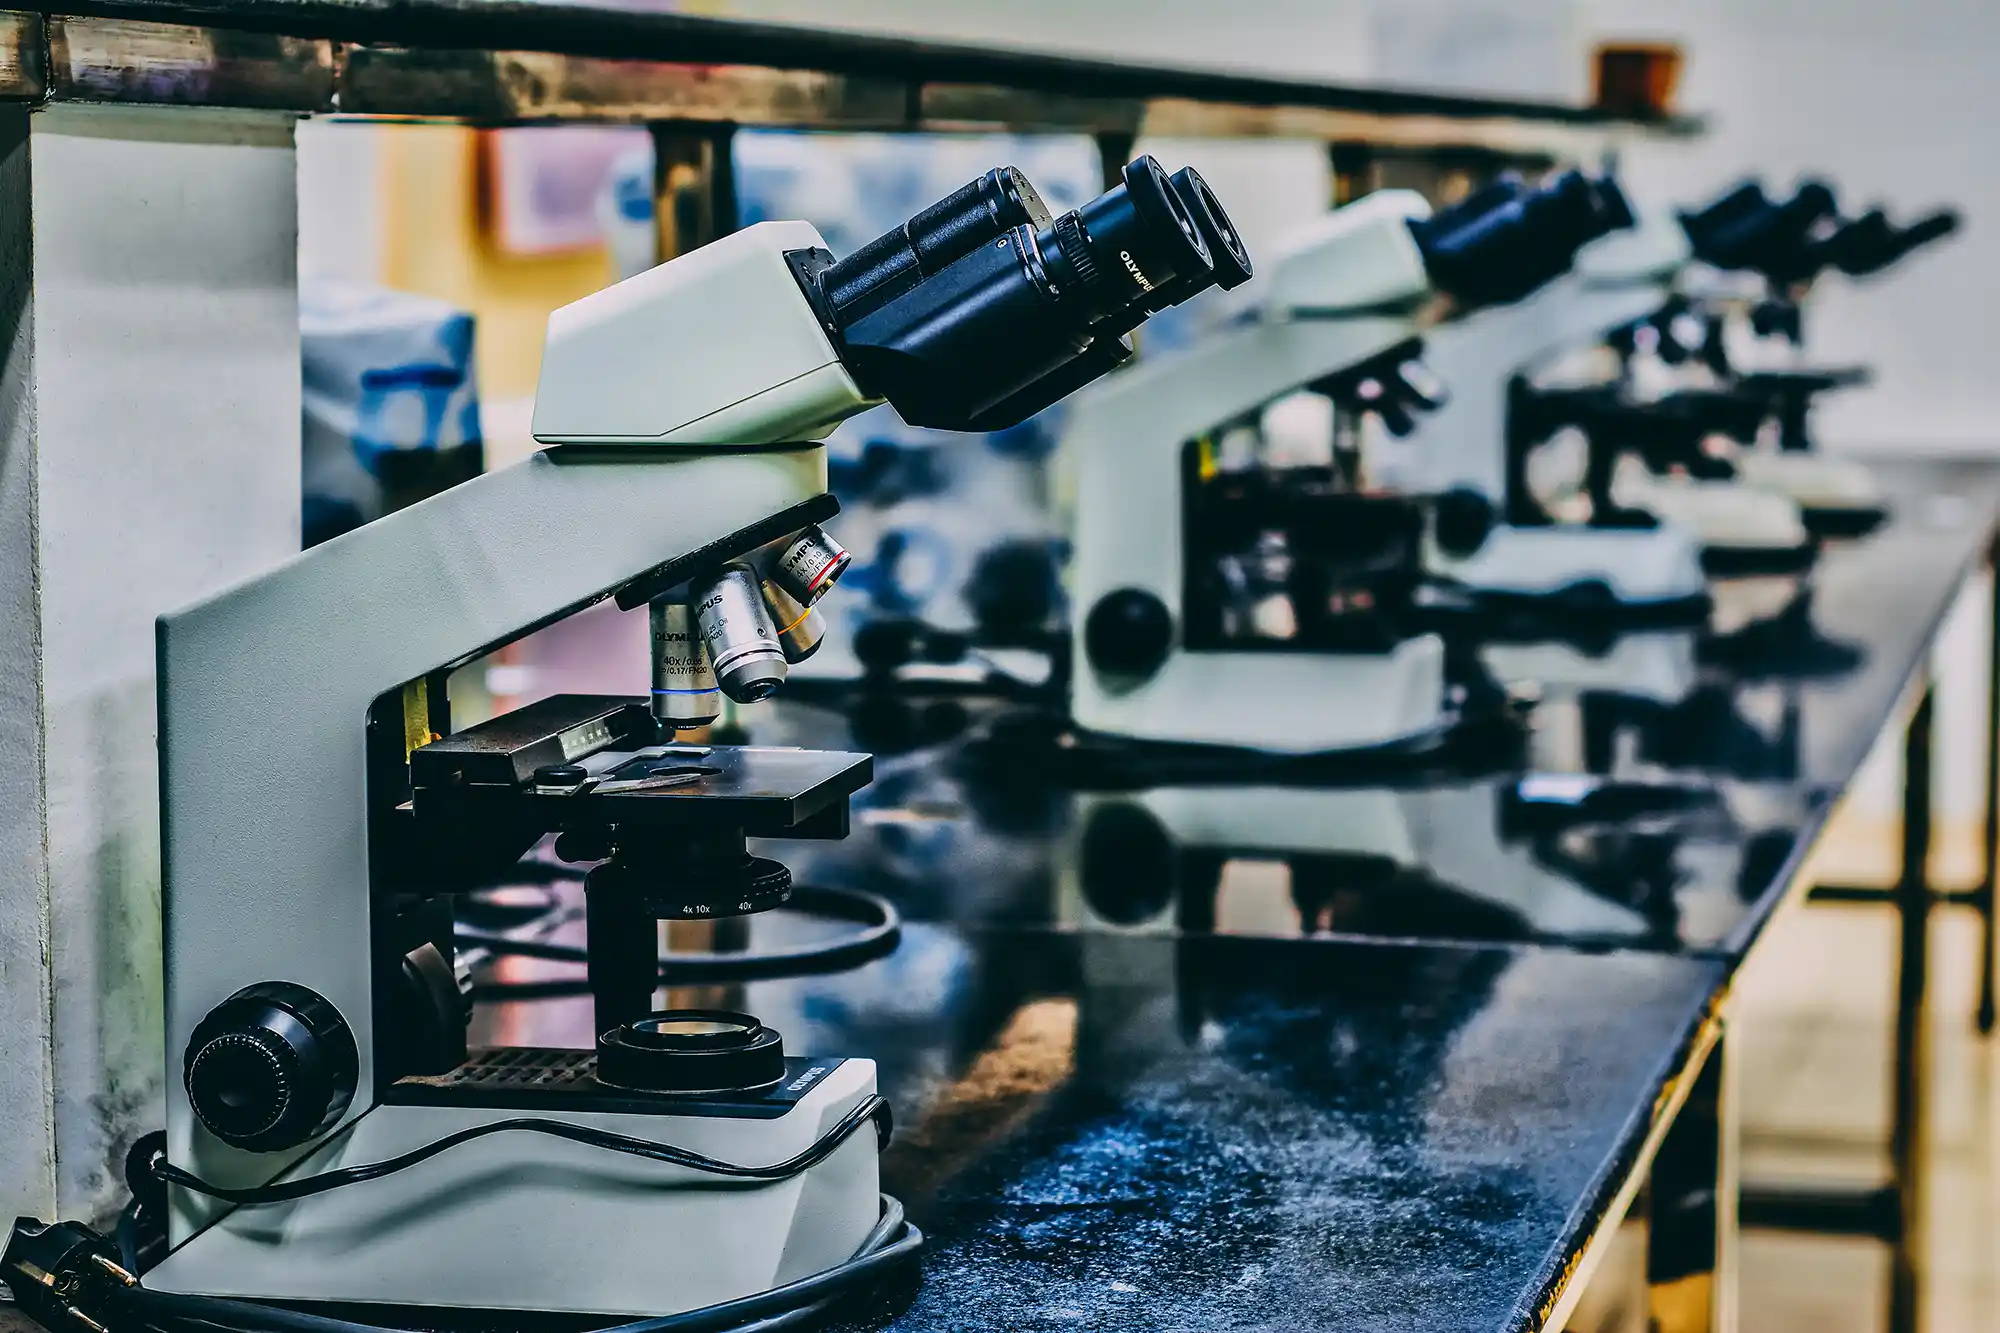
top-left (1410, 170), bottom-right (1634, 308)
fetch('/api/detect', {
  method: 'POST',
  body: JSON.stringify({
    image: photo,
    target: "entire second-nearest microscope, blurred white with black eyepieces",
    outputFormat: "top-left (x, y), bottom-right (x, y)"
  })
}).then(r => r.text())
top-left (1062, 172), bottom-right (1624, 755)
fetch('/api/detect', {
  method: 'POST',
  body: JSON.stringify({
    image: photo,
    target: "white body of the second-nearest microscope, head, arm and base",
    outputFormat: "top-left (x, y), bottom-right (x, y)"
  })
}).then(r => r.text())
top-left (1062, 190), bottom-right (1444, 753)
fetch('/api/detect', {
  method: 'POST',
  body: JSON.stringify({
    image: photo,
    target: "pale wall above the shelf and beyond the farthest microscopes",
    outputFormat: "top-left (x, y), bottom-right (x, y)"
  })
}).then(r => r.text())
top-left (714, 0), bottom-right (2000, 448)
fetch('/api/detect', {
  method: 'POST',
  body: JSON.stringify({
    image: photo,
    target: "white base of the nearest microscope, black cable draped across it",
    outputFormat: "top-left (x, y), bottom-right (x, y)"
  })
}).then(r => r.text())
top-left (146, 1059), bottom-right (880, 1317)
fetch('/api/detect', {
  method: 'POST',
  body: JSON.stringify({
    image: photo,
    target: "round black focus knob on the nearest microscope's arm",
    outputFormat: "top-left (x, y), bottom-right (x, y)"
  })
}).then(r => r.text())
top-left (182, 981), bottom-right (360, 1153)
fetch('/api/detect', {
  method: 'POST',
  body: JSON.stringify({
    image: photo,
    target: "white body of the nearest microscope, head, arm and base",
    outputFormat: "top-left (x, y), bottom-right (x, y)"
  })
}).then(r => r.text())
top-left (146, 222), bottom-right (878, 1313)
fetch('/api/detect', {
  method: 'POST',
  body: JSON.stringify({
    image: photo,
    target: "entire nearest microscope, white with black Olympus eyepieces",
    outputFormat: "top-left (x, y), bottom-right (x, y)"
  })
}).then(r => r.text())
top-left (0, 156), bottom-right (1242, 1329)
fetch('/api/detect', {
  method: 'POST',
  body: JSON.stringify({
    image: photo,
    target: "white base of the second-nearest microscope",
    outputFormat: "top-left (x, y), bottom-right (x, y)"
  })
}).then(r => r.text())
top-left (1072, 634), bottom-right (1448, 755)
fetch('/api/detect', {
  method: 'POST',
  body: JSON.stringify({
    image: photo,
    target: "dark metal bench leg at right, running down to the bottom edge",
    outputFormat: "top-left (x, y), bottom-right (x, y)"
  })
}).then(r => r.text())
top-left (1888, 681), bottom-right (1934, 1333)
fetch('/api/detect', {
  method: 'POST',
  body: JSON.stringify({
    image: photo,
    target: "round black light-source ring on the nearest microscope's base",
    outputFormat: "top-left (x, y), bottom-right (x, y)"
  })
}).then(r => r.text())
top-left (598, 1009), bottom-right (784, 1097)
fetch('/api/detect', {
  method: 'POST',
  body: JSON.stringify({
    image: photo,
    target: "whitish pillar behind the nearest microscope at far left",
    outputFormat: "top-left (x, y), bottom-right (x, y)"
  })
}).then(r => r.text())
top-left (0, 106), bottom-right (300, 1217)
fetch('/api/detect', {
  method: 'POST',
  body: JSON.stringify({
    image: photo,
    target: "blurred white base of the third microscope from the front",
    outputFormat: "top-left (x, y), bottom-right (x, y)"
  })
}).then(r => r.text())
top-left (1438, 522), bottom-right (1708, 620)
